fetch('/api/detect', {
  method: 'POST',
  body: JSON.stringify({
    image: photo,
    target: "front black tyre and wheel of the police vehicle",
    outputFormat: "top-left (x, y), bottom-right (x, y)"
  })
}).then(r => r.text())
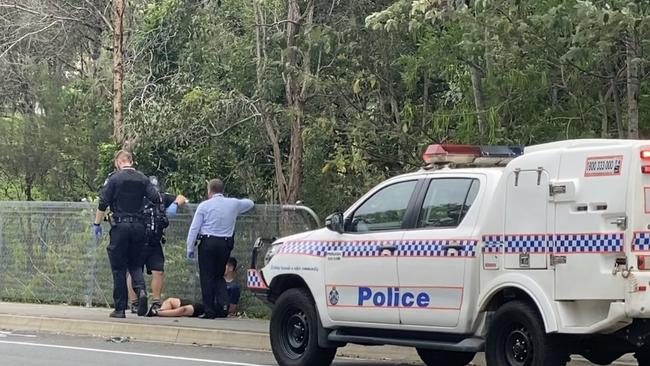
top-left (271, 288), bottom-right (336, 366)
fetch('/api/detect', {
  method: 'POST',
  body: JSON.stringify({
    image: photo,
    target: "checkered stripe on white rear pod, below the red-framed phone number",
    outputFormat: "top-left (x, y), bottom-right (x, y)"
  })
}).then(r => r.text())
top-left (554, 233), bottom-right (623, 254)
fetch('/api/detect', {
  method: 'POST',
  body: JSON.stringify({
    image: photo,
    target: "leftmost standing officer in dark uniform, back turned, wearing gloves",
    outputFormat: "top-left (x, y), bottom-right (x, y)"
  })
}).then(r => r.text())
top-left (94, 150), bottom-right (161, 318)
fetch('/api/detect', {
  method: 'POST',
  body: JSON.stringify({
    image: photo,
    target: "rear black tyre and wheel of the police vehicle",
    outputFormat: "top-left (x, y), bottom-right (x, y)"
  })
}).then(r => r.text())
top-left (485, 301), bottom-right (569, 366)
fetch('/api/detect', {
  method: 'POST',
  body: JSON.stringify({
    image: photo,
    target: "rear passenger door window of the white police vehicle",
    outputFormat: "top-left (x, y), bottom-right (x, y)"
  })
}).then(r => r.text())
top-left (417, 178), bottom-right (480, 228)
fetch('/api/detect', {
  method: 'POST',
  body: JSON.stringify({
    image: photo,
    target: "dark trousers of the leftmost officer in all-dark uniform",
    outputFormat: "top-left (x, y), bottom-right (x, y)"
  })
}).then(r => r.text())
top-left (106, 223), bottom-right (145, 310)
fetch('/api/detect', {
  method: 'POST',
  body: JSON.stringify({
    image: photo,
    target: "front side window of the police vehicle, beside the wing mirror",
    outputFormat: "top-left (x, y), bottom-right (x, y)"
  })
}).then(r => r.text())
top-left (348, 180), bottom-right (417, 233)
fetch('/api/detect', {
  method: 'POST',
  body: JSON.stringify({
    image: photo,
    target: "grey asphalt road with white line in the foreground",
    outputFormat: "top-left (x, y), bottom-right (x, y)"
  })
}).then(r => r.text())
top-left (0, 331), bottom-right (633, 366)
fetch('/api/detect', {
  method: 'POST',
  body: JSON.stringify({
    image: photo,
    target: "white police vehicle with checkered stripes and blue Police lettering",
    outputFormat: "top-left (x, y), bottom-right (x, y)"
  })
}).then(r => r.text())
top-left (248, 140), bottom-right (650, 366)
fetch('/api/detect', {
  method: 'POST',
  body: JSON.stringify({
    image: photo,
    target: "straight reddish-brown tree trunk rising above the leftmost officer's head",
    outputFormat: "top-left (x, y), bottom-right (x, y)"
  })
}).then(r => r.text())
top-left (113, 0), bottom-right (125, 145)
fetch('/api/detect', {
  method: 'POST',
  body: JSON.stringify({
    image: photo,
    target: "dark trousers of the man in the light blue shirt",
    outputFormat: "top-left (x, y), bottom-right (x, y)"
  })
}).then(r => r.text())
top-left (199, 237), bottom-right (234, 316)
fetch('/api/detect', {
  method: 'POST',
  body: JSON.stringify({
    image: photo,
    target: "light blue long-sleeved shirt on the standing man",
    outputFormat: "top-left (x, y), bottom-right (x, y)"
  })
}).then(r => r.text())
top-left (187, 194), bottom-right (255, 254)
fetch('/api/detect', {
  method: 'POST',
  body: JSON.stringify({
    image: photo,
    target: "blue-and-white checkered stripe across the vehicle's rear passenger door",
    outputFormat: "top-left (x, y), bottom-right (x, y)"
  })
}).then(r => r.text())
top-left (397, 240), bottom-right (476, 257)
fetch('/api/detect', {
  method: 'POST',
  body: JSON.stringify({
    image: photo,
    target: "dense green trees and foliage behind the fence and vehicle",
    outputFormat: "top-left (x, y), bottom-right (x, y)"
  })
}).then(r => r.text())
top-left (0, 0), bottom-right (650, 316)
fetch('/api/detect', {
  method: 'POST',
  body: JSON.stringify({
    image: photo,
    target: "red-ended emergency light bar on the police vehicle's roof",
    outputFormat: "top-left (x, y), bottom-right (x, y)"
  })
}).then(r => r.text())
top-left (422, 144), bottom-right (524, 166)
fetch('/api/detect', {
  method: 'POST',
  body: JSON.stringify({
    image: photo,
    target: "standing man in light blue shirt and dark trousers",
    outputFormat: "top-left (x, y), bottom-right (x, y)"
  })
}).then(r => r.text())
top-left (187, 179), bottom-right (255, 319)
